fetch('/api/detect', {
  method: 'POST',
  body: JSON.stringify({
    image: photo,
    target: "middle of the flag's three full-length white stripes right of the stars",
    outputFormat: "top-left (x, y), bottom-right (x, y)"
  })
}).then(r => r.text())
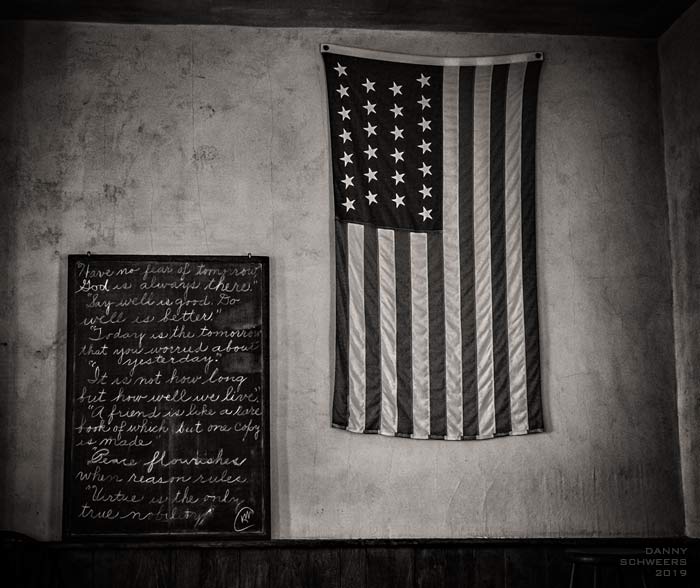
top-left (474, 67), bottom-right (496, 437)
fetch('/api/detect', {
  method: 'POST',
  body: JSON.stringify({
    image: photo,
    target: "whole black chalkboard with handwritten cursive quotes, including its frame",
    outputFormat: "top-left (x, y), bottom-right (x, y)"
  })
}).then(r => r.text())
top-left (63, 255), bottom-right (270, 539)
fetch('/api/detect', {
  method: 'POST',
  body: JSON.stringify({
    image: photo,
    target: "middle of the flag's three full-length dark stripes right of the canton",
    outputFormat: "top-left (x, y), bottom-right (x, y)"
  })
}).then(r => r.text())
top-left (489, 65), bottom-right (511, 434)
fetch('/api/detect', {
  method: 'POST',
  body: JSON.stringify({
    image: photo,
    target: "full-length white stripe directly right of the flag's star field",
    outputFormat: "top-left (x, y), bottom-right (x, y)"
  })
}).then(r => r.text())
top-left (442, 67), bottom-right (463, 439)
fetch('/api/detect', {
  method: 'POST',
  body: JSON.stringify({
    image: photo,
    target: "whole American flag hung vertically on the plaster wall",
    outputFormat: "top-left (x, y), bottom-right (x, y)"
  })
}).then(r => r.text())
top-left (321, 45), bottom-right (544, 440)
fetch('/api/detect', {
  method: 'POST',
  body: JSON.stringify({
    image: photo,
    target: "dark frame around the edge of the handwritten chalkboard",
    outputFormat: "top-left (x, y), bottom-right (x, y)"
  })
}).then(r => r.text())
top-left (62, 253), bottom-right (271, 541)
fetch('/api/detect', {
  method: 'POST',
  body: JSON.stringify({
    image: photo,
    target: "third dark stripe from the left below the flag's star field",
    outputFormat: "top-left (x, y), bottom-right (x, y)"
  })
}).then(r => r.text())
top-left (394, 231), bottom-right (413, 435)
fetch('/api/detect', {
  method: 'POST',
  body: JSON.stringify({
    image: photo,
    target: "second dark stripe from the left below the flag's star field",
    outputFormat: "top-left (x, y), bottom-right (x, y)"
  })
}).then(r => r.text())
top-left (365, 225), bottom-right (382, 432)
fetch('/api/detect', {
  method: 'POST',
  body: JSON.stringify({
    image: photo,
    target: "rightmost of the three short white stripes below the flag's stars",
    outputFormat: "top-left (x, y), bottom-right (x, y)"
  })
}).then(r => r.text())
top-left (411, 233), bottom-right (430, 439)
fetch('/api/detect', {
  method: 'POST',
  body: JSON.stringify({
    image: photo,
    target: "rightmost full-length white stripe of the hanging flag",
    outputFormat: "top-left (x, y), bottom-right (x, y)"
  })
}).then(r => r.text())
top-left (505, 63), bottom-right (528, 432)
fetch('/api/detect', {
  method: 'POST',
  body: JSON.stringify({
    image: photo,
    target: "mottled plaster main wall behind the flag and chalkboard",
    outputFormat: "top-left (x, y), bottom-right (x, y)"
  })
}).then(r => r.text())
top-left (0, 23), bottom-right (683, 538)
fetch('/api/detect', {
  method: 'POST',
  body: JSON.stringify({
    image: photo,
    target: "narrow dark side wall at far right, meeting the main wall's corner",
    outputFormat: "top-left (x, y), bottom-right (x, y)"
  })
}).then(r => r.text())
top-left (659, 2), bottom-right (700, 537)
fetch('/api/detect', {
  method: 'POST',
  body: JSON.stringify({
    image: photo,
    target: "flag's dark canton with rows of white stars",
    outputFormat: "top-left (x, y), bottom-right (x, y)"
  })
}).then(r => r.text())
top-left (323, 53), bottom-right (442, 231)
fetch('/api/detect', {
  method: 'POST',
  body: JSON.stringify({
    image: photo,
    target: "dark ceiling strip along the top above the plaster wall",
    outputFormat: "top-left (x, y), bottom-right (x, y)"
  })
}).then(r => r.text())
top-left (3, 0), bottom-right (693, 37)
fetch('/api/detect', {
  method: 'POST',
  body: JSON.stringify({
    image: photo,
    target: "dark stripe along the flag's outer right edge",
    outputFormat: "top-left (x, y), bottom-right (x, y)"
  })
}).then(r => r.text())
top-left (521, 61), bottom-right (544, 430)
